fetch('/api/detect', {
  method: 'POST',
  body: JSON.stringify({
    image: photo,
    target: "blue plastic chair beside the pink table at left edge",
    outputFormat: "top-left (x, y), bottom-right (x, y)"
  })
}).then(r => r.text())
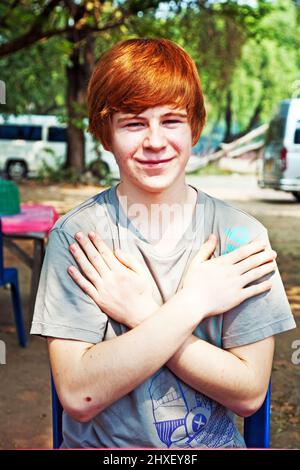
top-left (0, 218), bottom-right (27, 348)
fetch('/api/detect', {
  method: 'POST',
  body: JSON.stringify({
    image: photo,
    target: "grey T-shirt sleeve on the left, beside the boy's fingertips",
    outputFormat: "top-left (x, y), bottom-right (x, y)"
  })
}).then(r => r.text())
top-left (30, 228), bottom-right (108, 344)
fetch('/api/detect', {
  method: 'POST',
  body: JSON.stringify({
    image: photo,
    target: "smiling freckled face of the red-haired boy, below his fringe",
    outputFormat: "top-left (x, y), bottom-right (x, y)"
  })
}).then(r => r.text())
top-left (110, 106), bottom-right (192, 192)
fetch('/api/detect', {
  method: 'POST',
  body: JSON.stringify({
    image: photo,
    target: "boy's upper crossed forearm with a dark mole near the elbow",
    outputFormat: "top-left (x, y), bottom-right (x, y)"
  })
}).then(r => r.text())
top-left (63, 293), bottom-right (206, 421)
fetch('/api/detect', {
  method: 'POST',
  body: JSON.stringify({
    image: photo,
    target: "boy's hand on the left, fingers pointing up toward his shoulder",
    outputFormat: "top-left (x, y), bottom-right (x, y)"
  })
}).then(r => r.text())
top-left (68, 232), bottom-right (158, 328)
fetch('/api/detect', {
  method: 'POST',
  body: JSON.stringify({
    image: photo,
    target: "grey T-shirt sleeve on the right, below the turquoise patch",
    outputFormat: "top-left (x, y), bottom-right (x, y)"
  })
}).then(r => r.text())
top-left (222, 229), bottom-right (296, 349)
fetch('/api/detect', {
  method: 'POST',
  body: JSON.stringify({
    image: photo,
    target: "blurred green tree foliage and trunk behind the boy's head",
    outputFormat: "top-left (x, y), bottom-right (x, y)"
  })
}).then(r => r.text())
top-left (0, 0), bottom-right (300, 172)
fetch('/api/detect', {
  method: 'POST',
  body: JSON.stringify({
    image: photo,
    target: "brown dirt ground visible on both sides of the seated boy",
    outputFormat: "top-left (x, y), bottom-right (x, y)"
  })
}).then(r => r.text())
top-left (0, 178), bottom-right (300, 449)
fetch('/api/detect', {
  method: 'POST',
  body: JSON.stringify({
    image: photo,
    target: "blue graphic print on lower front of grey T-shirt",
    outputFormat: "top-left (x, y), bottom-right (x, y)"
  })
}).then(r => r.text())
top-left (149, 368), bottom-right (235, 448)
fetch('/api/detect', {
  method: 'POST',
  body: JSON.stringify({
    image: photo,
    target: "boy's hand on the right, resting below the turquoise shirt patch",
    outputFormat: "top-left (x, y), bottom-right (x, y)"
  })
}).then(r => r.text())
top-left (182, 235), bottom-right (277, 318)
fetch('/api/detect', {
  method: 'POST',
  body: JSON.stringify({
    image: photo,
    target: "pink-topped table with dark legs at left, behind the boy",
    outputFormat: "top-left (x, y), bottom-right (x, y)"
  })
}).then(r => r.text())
top-left (1, 204), bottom-right (59, 314)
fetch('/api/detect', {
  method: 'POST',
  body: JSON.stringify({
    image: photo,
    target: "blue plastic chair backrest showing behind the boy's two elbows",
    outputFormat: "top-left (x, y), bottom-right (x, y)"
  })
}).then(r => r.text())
top-left (51, 376), bottom-right (271, 449)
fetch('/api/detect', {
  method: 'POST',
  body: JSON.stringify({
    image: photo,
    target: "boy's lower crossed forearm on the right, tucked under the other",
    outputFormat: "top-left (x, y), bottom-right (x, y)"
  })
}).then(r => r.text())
top-left (166, 335), bottom-right (260, 416)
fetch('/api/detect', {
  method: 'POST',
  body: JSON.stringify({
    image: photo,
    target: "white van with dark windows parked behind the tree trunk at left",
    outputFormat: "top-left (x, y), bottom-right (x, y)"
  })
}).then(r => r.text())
top-left (0, 115), bottom-right (119, 179)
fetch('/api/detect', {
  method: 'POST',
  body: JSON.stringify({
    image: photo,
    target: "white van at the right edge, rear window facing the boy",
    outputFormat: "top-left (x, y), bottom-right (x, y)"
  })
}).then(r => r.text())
top-left (258, 98), bottom-right (300, 201)
